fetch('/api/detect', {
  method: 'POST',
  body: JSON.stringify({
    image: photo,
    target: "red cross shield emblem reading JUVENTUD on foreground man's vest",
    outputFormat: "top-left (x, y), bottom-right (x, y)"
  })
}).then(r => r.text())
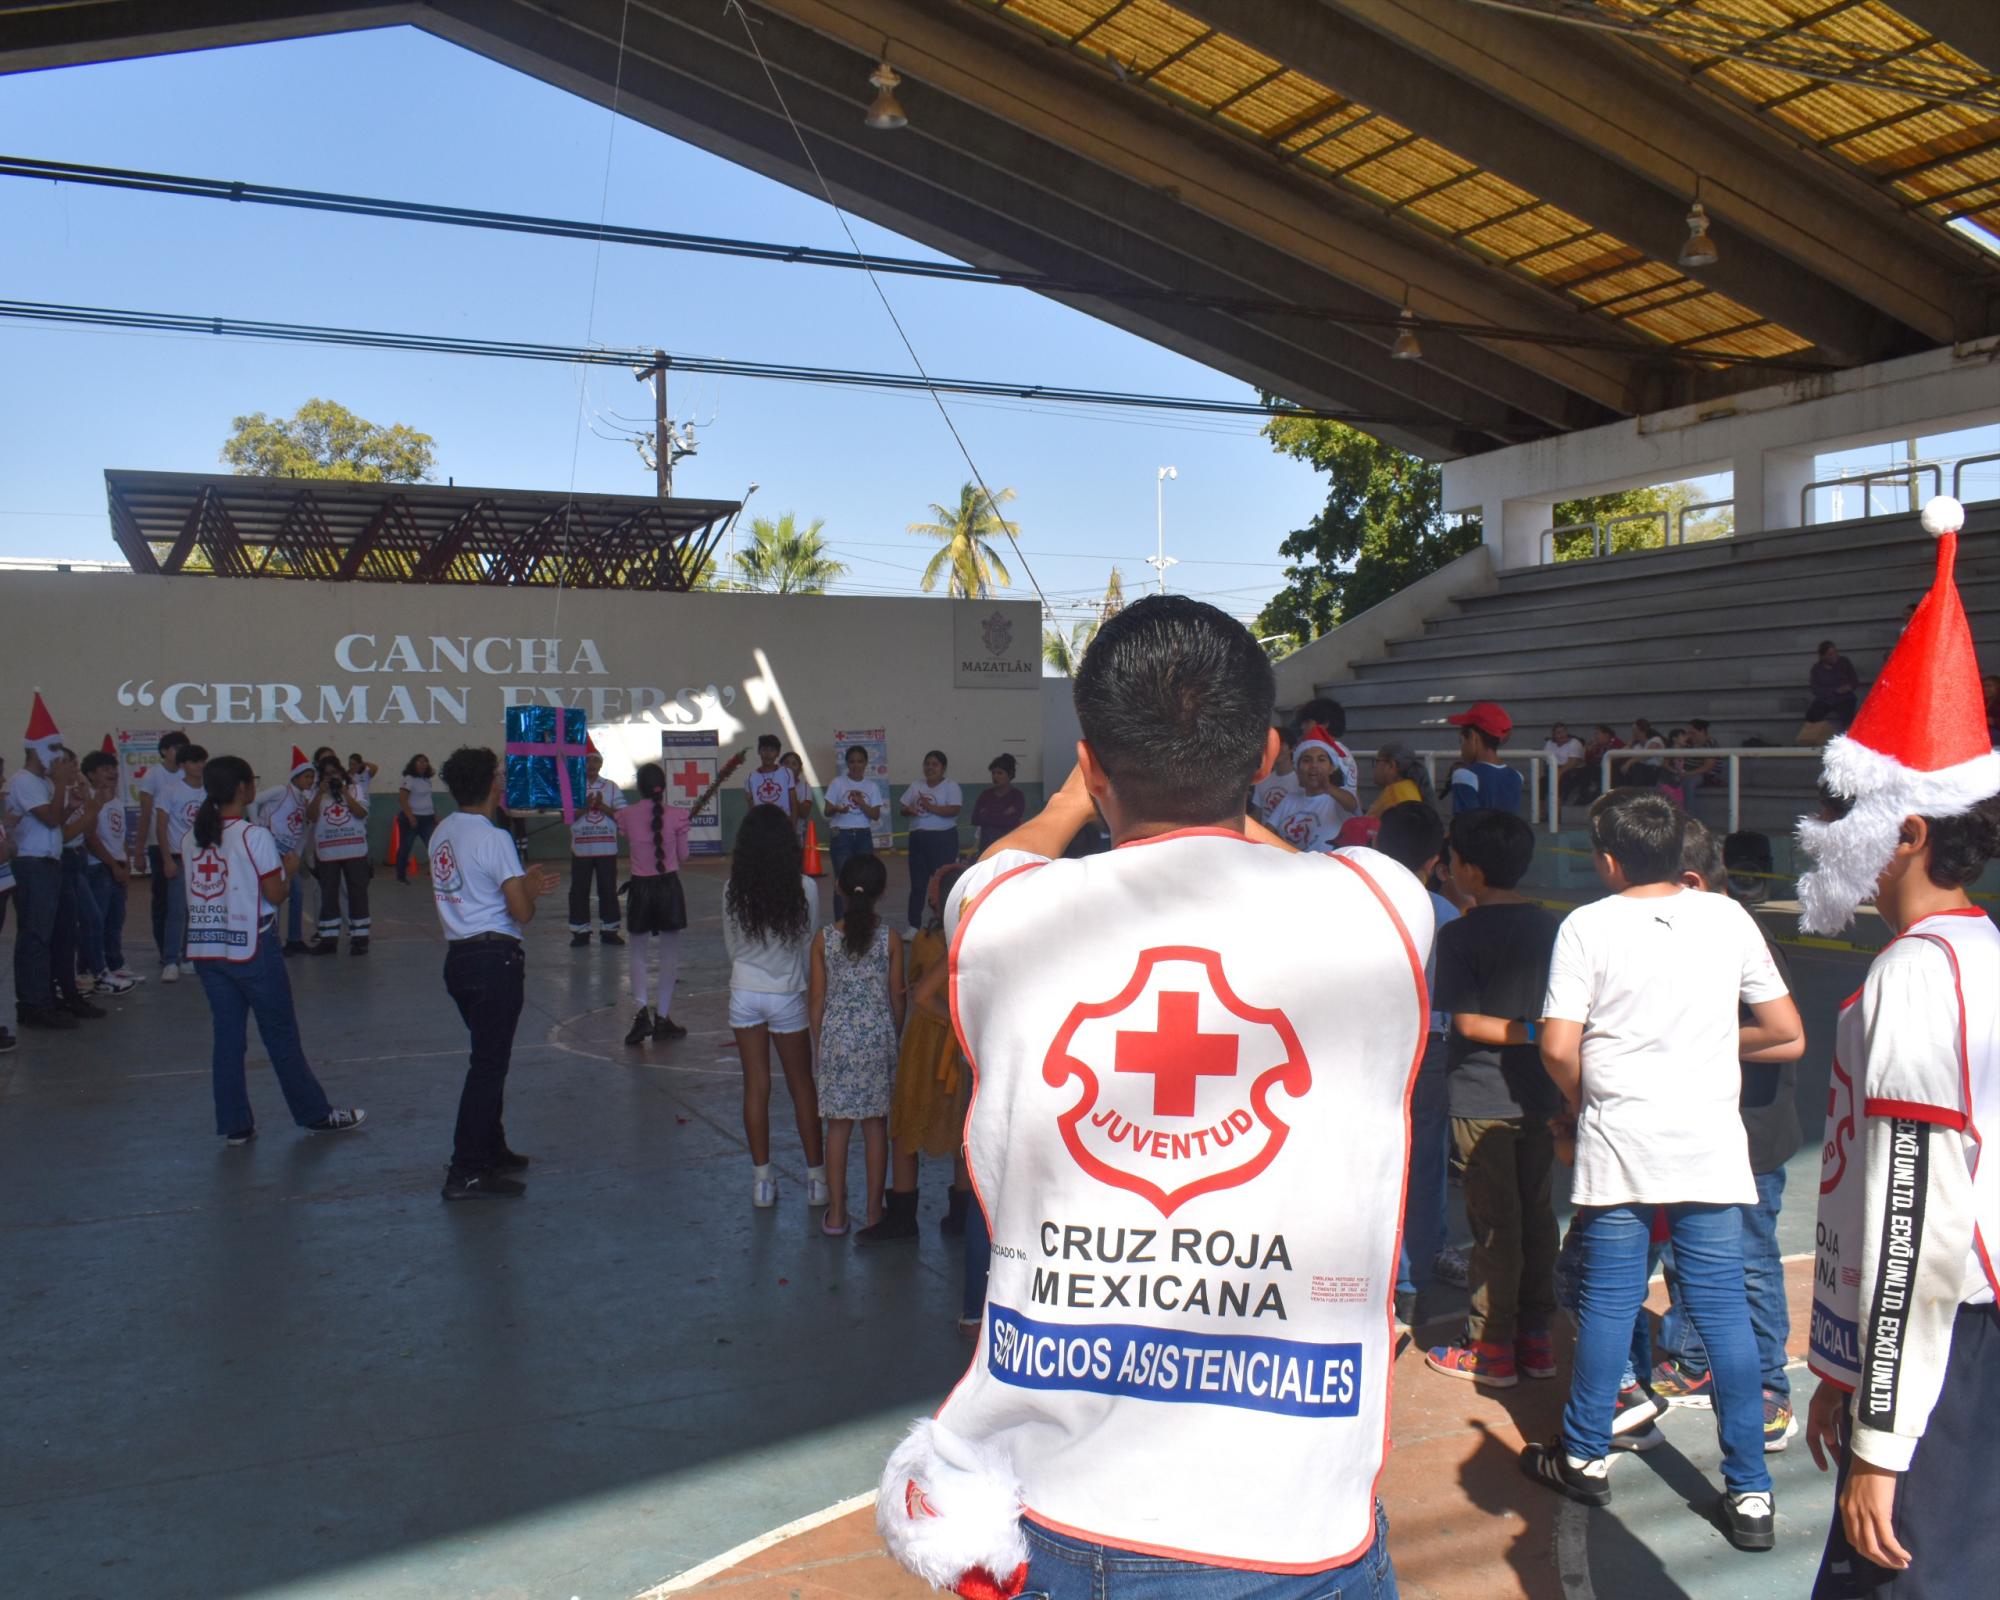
top-left (1042, 946), bottom-right (1312, 1216)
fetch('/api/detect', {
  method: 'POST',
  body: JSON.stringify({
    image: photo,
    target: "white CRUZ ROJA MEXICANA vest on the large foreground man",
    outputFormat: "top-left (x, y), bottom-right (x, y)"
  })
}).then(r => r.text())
top-left (938, 830), bottom-right (1430, 1572)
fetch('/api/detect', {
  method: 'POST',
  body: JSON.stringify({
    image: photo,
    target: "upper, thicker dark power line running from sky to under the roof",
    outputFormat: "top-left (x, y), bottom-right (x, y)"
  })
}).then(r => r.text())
top-left (0, 156), bottom-right (1828, 372)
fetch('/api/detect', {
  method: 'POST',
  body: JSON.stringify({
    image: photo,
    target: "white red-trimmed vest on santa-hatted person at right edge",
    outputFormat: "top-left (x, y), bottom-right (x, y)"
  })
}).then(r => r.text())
top-left (1808, 912), bottom-right (2000, 1390)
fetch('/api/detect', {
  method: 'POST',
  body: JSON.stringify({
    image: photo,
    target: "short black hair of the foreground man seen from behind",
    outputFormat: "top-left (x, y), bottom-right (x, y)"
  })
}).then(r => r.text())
top-left (1070, 594), bottom-right (1278, 824)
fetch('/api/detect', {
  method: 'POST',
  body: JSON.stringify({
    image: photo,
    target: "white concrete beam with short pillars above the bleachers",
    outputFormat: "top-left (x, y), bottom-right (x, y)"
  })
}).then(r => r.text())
top-left (1444, 338), bottom-right (2000, 568)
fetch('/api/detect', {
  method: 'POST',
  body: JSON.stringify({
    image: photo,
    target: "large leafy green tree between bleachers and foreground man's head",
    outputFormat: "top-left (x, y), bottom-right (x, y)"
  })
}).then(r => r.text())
top-left (1256, 416), bottom-right (1480, 660)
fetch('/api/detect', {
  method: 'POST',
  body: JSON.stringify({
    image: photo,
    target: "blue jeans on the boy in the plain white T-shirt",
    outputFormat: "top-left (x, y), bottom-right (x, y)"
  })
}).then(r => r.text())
top-left (1562, 1202), bottom-right (1770, 1492)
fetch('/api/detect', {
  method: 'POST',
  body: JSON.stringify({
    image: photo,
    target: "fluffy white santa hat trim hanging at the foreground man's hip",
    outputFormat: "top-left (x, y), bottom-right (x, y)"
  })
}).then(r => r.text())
top-left (876, 1416), bottom-right (1028, 1600)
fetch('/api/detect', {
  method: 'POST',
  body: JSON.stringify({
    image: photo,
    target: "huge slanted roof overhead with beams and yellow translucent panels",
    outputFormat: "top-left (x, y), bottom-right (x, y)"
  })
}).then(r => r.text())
top-left (0, 0), bottom-right (2000, 460)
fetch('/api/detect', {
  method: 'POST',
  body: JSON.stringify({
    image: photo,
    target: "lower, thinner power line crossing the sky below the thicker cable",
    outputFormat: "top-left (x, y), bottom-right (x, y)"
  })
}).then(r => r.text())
top-left (0, 300), bottom-right (1418, 424)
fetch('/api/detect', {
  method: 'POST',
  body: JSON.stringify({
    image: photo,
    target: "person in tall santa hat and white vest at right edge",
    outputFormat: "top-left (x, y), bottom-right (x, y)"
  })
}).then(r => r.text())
top-left (1800, 496), bottom-right (2000, 1600)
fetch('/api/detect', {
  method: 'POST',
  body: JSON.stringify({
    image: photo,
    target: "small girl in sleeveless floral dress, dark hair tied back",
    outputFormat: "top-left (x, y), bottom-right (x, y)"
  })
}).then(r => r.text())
top-left (808, 856), bottom-right (914, 1234)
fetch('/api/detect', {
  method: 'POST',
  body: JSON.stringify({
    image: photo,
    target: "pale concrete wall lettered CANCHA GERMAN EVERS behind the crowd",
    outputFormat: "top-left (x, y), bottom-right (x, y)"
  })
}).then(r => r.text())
top-left (0, 572), bottom-right (1066, 820)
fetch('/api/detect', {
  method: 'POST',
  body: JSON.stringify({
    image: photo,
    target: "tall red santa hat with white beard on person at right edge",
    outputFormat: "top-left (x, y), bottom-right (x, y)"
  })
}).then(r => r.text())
top-left (1798, 494), bottom-right (2000, 934)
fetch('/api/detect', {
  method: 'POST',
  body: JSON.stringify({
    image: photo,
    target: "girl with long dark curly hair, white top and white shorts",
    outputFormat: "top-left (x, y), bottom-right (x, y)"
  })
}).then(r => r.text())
top-left (722, 806), bottom-right (826, 1206)
